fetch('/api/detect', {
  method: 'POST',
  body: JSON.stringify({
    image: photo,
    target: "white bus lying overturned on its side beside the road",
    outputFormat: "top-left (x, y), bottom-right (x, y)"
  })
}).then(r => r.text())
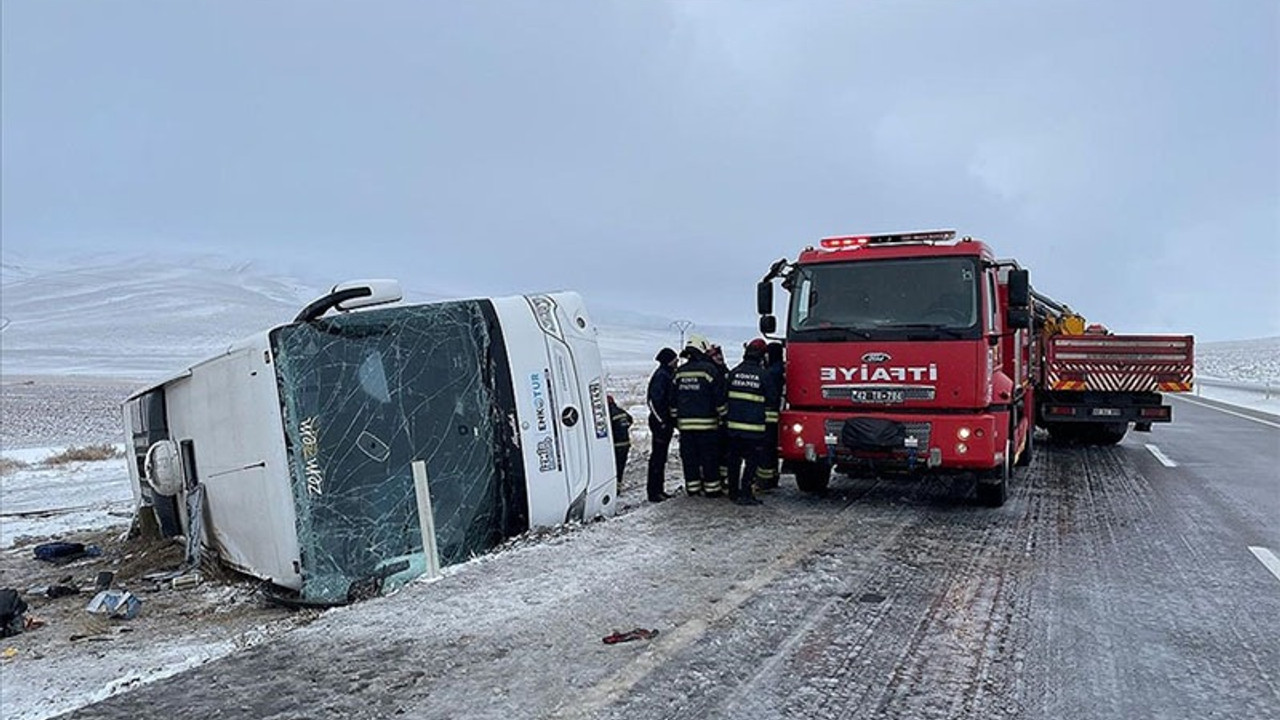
top-left (124, 281), bottom-right (617, 605)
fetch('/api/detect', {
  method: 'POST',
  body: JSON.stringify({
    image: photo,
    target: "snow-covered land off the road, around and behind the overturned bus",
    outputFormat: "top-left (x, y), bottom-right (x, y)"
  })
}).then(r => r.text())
top-left (0, 254), bottom-right (1280, 720)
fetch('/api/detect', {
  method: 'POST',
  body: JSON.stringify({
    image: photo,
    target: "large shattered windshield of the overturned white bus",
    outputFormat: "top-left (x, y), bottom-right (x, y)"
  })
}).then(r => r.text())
top-left (271, 301), bottom-right (529, 602)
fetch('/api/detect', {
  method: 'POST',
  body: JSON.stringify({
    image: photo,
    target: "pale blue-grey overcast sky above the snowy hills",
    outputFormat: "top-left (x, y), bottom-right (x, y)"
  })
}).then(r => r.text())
top-left (0, 0), bottom-right (1280, 341)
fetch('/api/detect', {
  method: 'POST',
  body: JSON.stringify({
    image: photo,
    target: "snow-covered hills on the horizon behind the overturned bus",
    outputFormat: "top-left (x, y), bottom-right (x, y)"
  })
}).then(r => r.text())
top-left (0, 254), bottom-right (751, 380)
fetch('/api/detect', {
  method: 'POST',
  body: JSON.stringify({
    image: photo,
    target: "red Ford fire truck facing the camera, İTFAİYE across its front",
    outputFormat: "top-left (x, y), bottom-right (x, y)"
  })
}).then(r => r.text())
top-left (756, 231), bottom-right (1036, 506)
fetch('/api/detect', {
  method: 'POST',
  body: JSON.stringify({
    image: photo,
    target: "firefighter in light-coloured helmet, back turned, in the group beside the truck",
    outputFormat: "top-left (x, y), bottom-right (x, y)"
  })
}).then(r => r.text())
top-left (676, 337), bottom-right (724, 497)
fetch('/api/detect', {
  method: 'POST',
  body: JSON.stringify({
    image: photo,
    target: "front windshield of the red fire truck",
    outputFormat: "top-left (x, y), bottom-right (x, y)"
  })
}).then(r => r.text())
top-left (787, 258), bottom-right (982, 341)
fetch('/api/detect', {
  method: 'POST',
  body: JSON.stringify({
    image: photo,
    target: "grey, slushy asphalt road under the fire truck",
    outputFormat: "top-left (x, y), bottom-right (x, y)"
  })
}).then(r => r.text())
top-left (60, 401), bottom-right (1280, 720)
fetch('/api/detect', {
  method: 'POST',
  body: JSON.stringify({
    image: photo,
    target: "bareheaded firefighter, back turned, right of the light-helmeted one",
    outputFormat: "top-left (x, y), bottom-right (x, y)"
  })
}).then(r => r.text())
top-left (724, 338), bottom-right (778, 505)
